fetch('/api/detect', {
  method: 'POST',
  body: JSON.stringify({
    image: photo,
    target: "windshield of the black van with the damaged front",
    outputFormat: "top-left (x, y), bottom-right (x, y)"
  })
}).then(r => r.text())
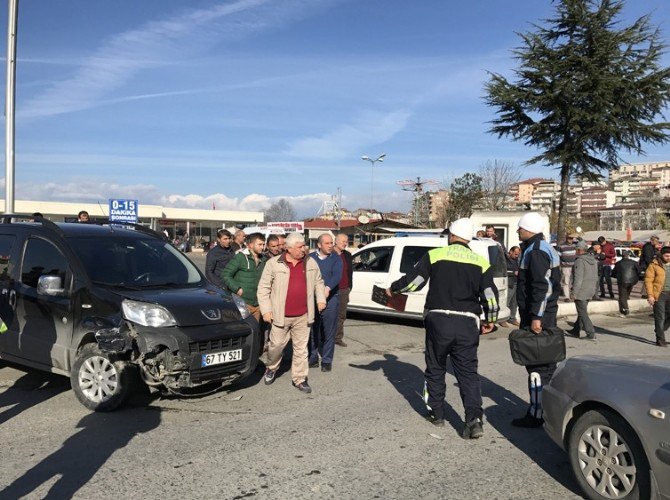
top-left (68, 236), bottom-right (202, 288)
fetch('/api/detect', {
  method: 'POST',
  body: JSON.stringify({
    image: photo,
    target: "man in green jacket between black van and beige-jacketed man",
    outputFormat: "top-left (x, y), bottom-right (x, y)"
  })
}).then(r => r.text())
top-left (226, 233), bottom-right (265, 323)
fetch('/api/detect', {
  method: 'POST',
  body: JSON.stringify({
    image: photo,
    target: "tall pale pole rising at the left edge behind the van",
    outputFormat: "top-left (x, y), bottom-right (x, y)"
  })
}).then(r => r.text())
top-left (5, 0), bottom-right (19, 214)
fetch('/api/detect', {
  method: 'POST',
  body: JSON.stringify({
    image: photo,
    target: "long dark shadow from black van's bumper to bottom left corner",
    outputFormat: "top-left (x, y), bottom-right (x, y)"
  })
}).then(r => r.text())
top-left (0, 408), bottom-right (161, 498)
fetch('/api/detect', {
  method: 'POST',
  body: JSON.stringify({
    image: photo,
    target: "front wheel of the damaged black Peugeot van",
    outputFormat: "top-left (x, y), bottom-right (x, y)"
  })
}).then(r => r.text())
top-left (70, 344), bottom-right (131, 411)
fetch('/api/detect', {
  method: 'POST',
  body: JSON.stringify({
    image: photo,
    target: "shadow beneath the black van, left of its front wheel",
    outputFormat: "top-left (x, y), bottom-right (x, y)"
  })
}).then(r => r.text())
top-left (0, 370), bottom-right (70, 425)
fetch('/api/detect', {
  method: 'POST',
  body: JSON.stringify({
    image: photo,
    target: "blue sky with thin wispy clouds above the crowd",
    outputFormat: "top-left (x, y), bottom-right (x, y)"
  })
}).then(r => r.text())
top-left (0, 0), bottom-right (670, 216)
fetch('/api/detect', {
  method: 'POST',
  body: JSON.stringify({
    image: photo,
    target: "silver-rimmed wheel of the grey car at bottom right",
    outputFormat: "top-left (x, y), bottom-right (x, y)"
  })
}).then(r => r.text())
top-left (568, 410), bottom-right (650, 500)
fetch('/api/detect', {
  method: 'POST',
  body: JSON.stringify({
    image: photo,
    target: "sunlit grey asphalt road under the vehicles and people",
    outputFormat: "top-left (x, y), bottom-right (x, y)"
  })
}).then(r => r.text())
top-left (0, 290), bottom-right (670, 499)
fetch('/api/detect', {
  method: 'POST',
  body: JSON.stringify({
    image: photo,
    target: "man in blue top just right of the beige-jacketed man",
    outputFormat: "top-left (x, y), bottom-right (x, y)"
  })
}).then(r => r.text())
top-left (309, 233), bottom-right (342, 372)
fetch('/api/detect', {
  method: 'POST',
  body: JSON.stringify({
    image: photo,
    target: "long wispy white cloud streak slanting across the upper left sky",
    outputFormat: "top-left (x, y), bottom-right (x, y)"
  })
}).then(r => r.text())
top-left (18, 0), bottom-right (342, 117)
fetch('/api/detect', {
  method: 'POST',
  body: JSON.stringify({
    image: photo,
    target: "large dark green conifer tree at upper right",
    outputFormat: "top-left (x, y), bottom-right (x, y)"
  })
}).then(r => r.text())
top-left (486, 0), bottom-right (670, 238)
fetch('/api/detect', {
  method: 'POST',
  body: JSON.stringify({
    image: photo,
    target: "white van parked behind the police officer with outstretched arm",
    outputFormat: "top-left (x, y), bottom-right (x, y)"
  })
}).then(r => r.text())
top-left (347, 236), bottom-right (509, 321)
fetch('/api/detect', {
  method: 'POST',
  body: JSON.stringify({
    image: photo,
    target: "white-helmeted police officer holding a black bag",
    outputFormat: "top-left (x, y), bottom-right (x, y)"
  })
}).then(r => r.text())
top-left (512, 212), bottom-right (561, 427)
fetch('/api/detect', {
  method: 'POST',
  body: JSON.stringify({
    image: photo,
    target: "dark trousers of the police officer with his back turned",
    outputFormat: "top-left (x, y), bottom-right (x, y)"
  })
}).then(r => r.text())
top-left (424, 312), bottom-right (484, 422)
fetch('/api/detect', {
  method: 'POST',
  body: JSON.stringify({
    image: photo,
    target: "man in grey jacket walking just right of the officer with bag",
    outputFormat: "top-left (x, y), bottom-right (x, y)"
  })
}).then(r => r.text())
top-left (567, 241), bottom-right (598, 340)
